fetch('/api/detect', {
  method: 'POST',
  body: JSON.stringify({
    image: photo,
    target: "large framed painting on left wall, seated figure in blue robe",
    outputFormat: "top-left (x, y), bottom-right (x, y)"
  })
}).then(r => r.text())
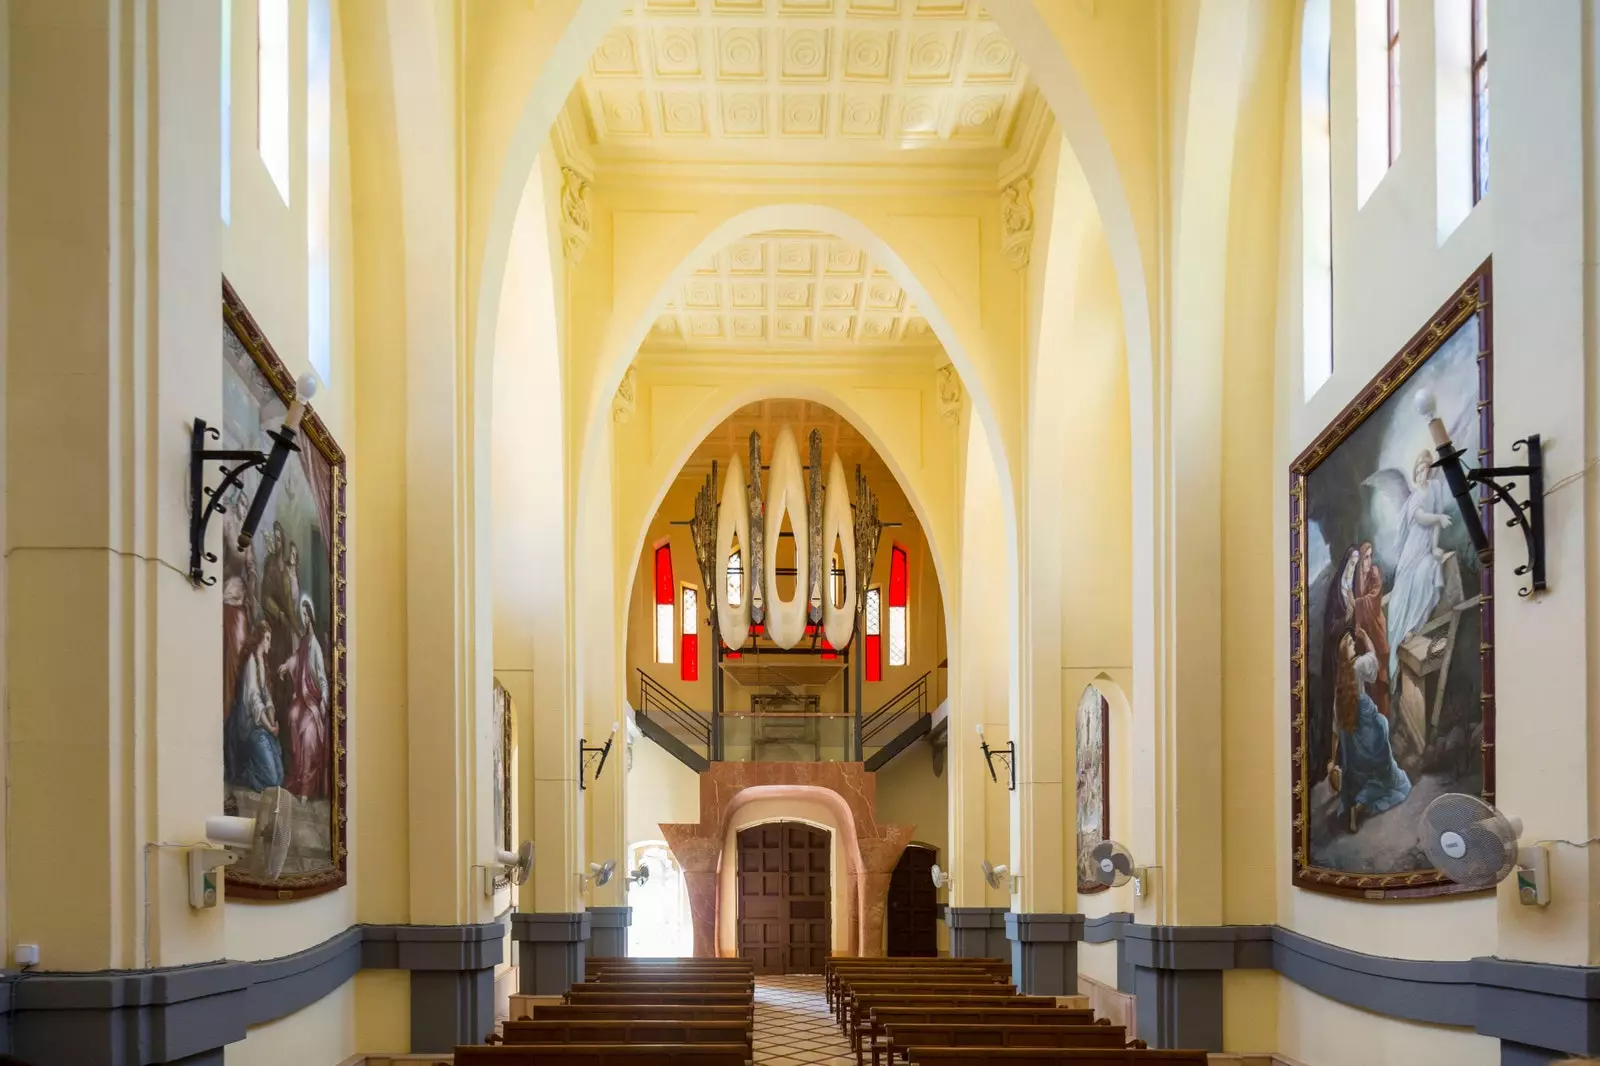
top-left (218, 279), bottom-right (349, 900)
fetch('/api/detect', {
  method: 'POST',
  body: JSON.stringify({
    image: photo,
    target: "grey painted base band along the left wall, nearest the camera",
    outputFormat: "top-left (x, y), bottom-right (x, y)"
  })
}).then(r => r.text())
top-left (0, 922), bottom-right (506, 1066)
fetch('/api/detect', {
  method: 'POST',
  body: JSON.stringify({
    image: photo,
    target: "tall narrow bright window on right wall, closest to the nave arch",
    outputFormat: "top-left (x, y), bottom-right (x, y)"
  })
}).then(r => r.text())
top-left (1301, 0), bottom-right (1333, 400)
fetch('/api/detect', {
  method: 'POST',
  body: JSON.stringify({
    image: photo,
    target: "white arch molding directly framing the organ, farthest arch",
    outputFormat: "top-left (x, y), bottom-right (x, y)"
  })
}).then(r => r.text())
top-left (619, 378), bottom-right (958, 653)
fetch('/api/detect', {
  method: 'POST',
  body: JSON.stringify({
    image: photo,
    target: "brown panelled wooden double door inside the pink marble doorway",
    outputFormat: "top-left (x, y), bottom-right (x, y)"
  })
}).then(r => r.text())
top-left (738, 821), bottom-right (832, 973)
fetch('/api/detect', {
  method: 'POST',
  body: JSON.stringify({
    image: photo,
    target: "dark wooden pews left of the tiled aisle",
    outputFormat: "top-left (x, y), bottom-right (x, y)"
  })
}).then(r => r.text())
top-left (456, 959), bottom-right (755, 1066)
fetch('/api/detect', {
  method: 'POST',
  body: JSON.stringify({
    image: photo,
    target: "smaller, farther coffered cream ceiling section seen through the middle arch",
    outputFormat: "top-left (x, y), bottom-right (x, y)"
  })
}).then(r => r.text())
top-left (645, 230), bottom-right (939, 351)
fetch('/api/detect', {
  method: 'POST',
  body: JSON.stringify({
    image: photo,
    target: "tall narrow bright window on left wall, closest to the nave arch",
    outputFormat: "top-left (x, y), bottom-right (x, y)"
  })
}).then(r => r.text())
top-left (306, 0), bottom-right (333, 386)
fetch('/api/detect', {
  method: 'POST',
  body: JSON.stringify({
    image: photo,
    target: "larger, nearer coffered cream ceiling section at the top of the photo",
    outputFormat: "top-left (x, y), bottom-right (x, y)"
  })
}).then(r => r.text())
top-left (578, 0), bottom-right (1037, 163)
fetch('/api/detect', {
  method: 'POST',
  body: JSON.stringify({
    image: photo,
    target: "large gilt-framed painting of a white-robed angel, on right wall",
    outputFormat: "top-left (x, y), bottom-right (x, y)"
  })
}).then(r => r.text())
top-left (1290, 262), bottom-right (1494, 900)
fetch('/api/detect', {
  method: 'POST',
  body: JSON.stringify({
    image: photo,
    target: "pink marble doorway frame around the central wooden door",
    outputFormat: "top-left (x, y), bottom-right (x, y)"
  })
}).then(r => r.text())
top-left (661, 762), bottom-right (917, 957)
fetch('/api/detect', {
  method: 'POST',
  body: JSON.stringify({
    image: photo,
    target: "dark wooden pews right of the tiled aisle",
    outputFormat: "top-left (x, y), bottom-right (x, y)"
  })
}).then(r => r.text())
top-left (824, 957), bottom-right (1206, 1066)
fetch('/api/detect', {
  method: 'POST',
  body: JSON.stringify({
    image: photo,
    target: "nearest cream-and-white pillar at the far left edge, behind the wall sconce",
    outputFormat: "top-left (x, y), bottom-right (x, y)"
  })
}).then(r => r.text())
top-left (0, 0), bottom-right (224, 973)
